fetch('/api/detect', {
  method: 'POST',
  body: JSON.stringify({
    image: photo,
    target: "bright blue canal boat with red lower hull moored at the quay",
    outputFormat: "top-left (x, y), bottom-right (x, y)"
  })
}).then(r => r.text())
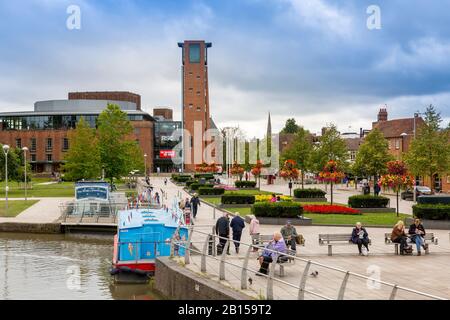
top-left (111, 205), bottom-right (188, 283)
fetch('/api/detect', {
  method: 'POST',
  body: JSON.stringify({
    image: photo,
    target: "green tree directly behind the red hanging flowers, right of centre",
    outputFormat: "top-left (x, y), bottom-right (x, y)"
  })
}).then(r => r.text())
top-left (312, 124), bottom-right (348, 172)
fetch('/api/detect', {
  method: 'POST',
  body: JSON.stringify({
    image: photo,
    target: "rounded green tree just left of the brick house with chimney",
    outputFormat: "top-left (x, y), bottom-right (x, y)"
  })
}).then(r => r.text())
top-left (352, 128), bottom-right (393, 195)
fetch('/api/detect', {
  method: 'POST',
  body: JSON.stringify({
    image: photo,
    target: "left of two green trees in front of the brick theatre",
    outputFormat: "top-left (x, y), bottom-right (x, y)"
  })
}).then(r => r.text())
top-left (63, 117), bottom-right (101, 181)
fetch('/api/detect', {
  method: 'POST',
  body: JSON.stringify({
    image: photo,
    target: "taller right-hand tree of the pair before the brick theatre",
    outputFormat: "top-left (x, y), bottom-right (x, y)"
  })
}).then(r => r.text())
top-left (97, 104), bottom-right (144, 184)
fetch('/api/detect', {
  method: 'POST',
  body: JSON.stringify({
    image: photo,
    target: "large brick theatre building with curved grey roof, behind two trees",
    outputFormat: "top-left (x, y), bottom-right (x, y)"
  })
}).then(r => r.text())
top-left (0, 92), bottom-right (155, 173)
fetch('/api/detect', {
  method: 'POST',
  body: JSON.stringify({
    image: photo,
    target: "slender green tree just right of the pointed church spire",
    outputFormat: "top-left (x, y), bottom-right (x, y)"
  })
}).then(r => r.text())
top-left (280, 127), bottom-right (313, 189)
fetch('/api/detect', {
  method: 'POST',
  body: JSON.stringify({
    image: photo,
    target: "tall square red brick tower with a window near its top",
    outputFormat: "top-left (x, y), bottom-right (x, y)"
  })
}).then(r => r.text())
top-left (178, 40), bottom-right (212, 171)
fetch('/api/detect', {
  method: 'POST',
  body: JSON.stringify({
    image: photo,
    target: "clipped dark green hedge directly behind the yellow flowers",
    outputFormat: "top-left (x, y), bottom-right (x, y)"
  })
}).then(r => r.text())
top-left (252, 202), bottom-right (303, 218)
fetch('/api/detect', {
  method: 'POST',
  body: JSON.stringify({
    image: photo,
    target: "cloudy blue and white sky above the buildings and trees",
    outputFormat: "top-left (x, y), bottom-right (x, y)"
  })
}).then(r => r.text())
top-left (0, 0), bottom-right (450, 138)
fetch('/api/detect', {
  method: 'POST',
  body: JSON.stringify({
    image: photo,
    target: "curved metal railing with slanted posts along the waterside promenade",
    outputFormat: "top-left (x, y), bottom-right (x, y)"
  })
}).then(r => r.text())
top-left (171, 227), bottom-right (447, 300)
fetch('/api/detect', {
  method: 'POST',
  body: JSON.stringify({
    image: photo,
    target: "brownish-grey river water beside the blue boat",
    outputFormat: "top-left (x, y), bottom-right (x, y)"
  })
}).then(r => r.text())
top-left (0, 233), bottom-right (160, 300)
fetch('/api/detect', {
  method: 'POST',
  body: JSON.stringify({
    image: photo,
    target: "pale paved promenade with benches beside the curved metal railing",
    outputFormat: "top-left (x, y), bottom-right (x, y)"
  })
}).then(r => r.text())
top-left (146, 177), bottom-right (450, 299)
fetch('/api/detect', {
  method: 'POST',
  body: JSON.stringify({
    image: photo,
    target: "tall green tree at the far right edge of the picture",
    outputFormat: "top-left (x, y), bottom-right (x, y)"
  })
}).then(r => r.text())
top-left (405, 105), bottom-right (450, 190)
